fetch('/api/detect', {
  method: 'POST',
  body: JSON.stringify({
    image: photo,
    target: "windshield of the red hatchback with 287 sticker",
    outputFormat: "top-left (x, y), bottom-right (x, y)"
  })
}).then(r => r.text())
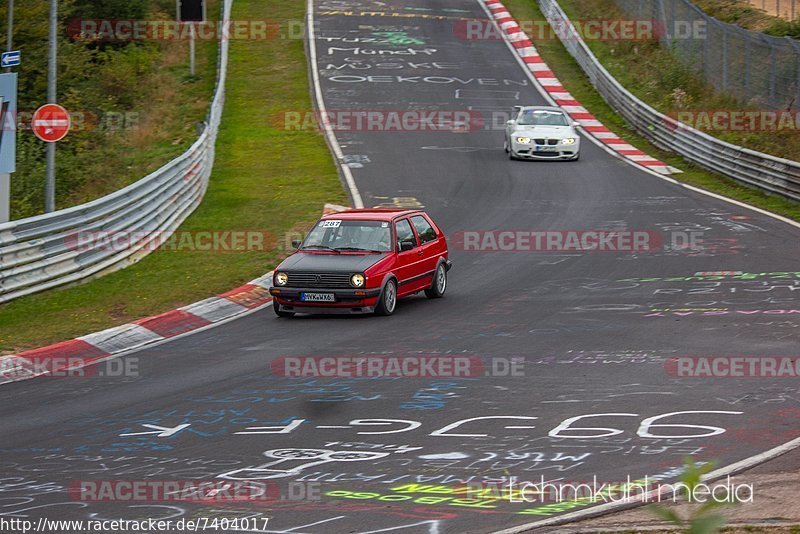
top-left (302, 219), bottom-right (392, 252)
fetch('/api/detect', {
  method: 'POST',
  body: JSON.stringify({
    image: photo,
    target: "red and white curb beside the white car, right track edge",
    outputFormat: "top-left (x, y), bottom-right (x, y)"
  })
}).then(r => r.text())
top-left (479, 0), bottom-right (674, 174)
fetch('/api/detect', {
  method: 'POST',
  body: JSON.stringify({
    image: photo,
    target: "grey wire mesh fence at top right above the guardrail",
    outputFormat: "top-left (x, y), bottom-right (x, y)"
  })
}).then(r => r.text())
top-left (614, 0), bottom-right (800, 110)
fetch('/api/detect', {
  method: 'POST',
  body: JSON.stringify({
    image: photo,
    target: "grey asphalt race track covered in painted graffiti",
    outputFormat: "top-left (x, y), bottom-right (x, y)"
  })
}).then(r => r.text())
top-left (0, 0), bottom-right (800, 533)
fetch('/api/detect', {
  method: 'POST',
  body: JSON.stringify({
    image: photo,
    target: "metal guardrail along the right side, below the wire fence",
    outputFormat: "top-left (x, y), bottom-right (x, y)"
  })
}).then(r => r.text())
top-left (538, 0), bottom-right (800, 201)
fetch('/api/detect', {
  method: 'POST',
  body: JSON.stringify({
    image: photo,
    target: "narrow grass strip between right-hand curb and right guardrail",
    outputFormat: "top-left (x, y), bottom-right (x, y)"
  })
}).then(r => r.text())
top-left (503, 0), bottom-right (800, 221)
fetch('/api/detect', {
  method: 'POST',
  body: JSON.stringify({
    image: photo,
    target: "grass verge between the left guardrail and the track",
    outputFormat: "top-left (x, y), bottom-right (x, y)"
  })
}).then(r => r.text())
top-left (0, 0), bottom-right (346, 353)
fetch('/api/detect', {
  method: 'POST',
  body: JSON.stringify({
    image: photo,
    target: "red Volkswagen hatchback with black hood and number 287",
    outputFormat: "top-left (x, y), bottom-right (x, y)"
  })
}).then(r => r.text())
top-left (270, 209), bottom-right (452, 317)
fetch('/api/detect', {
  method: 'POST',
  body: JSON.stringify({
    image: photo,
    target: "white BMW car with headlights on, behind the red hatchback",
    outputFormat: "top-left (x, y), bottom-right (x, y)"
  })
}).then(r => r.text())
top-left (503, 106), bottom-right (581, 161)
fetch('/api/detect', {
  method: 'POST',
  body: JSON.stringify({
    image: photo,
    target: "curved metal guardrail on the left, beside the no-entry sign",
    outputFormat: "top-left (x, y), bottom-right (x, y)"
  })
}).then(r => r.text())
top-left (0, 0), bottom-right (233, 303)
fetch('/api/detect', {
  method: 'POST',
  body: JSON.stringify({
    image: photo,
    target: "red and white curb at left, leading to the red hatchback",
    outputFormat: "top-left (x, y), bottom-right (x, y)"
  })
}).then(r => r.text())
top-left (0, 204), bottom-right (348, 385)
